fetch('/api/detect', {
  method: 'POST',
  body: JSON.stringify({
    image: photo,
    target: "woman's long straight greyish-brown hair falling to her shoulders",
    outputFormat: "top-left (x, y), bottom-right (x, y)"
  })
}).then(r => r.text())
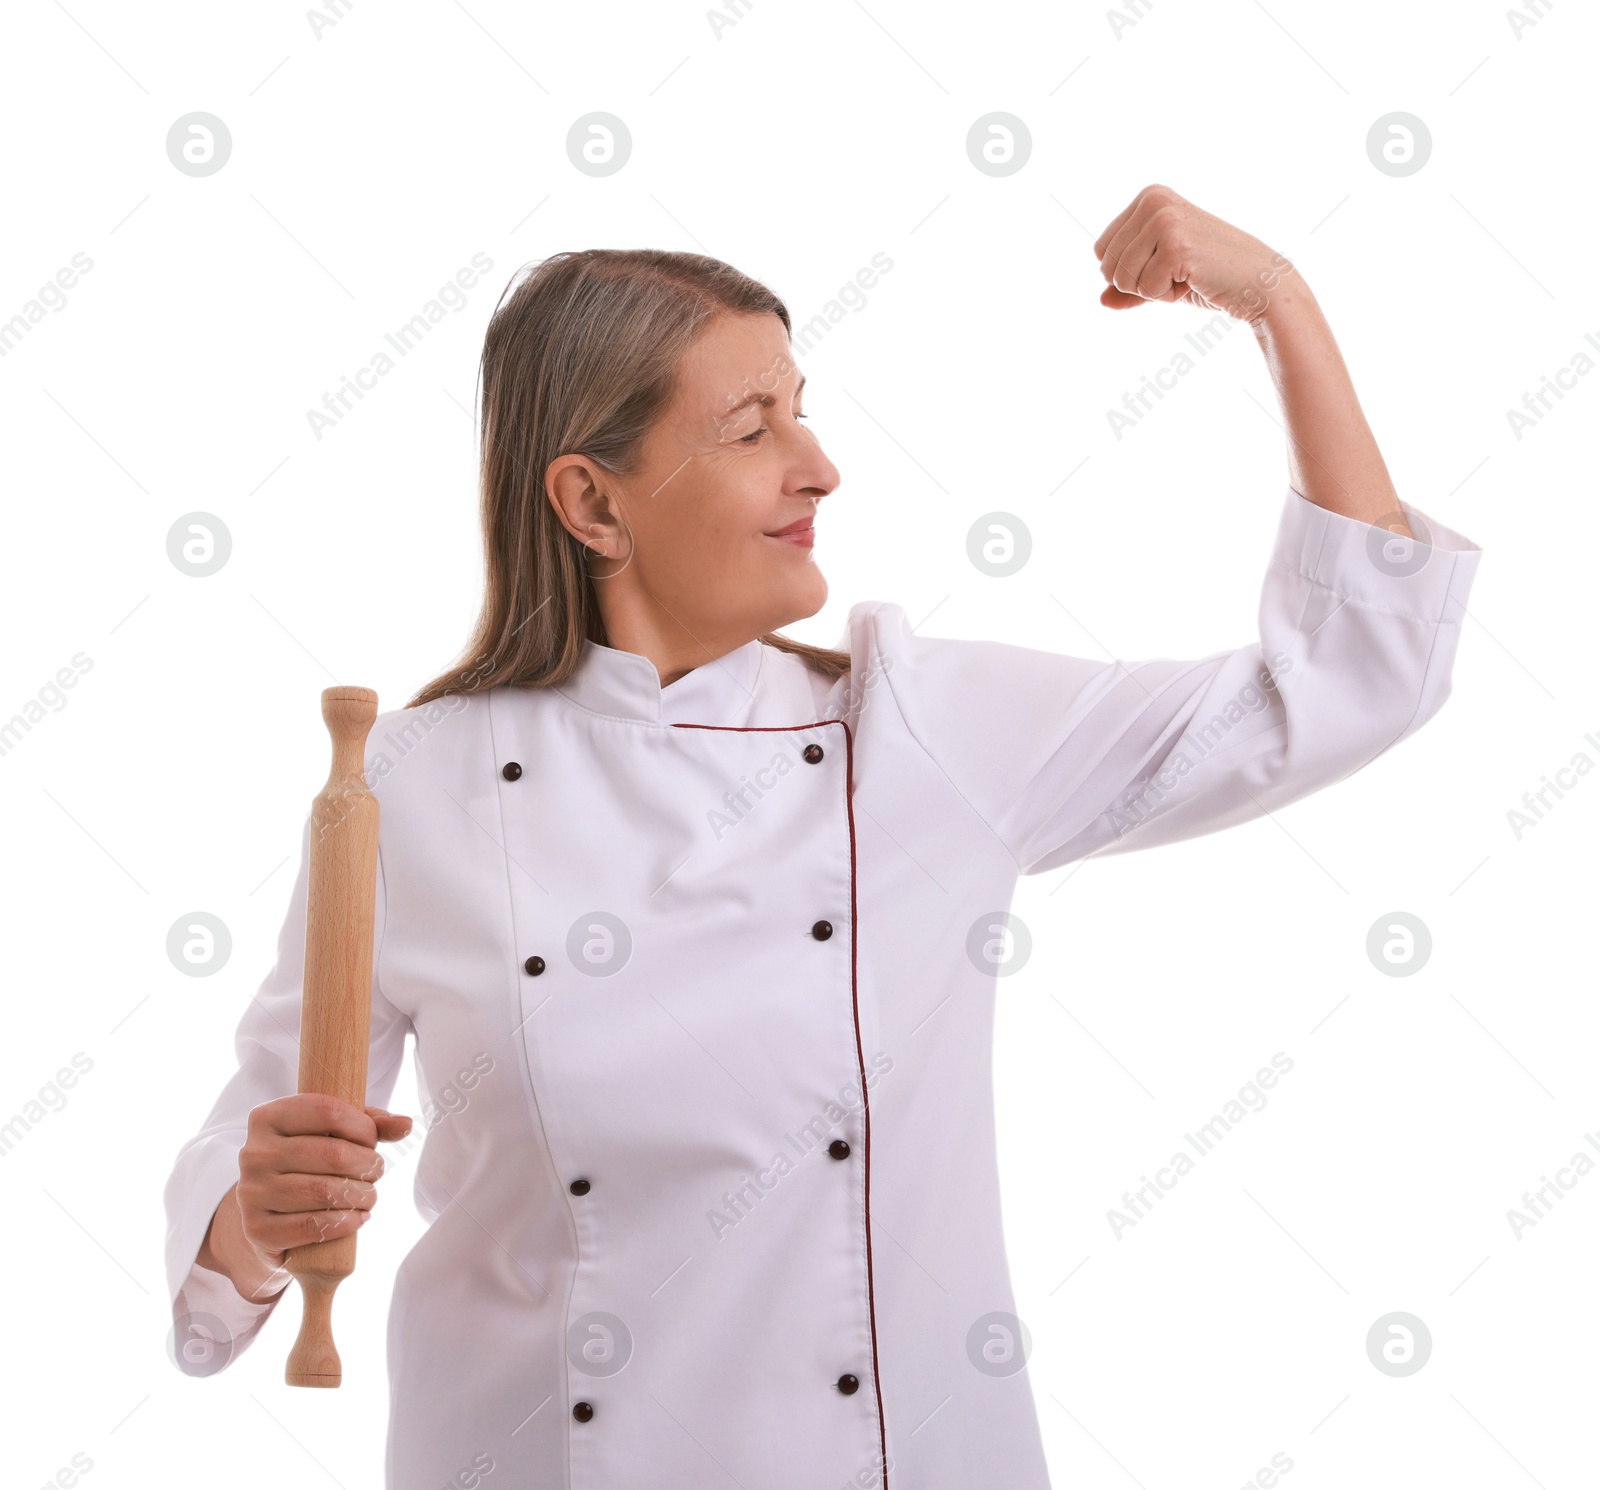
top-left (406, 248), bottom-right (850, 707)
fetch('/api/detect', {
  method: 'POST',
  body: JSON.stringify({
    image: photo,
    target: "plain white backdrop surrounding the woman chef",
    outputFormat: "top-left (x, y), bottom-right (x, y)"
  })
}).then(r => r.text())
top-left (0, 0), bottom-right (1600, 1490)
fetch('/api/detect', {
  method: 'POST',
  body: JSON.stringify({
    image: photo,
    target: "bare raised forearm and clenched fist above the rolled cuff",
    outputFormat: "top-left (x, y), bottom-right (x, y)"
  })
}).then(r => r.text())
top-left (1094, 186), bottom-right (1422, 534)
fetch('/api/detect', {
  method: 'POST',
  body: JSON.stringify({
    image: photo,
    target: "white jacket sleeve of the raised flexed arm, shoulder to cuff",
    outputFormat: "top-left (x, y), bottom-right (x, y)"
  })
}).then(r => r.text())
top-left (867, 488), bottom-right (1483, 874)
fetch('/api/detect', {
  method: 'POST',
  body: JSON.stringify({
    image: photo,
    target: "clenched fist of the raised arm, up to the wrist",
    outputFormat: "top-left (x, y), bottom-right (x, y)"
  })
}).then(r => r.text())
top-left (1094, 186), bottom-right (1304, 323)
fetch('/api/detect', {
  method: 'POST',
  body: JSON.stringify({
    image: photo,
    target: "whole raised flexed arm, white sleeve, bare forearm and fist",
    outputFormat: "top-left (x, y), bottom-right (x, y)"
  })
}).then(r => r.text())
top-left (850, 186), bottom-right (1483, 874)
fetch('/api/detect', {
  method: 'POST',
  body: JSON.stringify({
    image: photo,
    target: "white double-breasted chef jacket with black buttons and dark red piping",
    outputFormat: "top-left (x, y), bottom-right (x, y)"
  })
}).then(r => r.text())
top-left (166, 490), bottom-right (1482, 1490)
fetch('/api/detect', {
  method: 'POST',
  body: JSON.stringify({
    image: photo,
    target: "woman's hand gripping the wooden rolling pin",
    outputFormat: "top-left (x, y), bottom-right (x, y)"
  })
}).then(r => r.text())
top-left (235, 1091), bottom-right (411, 1269)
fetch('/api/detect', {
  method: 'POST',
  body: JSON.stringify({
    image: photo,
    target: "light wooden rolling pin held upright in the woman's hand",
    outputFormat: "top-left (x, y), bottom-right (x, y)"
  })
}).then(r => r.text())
top-left (283, 688), bottom-right (378, 1386)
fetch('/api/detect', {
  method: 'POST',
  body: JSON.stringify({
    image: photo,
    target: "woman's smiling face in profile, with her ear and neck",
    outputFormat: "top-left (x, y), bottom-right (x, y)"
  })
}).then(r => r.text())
top-left (546, 315), bottom-right (838, 682)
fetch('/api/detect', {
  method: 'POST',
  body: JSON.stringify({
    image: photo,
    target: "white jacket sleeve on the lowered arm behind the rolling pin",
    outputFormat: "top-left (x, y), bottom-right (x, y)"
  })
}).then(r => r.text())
top-left (165, 813), bottom-right (411, 1376)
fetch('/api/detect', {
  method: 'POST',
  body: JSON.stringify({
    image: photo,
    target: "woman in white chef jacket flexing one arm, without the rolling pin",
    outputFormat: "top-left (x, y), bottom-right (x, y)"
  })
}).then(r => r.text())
top-left (166, 186), bottom-right (1482, 1490)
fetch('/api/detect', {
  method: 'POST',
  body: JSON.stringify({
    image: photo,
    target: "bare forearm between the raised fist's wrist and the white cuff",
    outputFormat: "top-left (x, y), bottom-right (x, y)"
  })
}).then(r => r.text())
top-left (1251, 269), bottom-right (1411, 536)
